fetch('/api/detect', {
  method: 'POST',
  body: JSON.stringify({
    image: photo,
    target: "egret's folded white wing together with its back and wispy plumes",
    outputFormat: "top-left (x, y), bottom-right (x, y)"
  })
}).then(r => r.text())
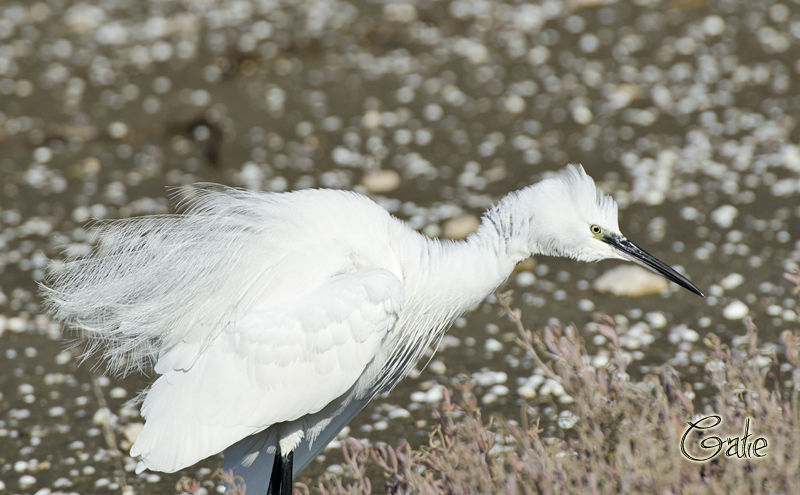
top-left (42, 186), bottom-right (410, 471)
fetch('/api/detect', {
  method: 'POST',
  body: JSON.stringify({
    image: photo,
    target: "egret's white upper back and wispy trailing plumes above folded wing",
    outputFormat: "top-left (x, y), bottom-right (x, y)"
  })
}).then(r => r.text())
top-left (42, 186), bottom-right (391, 374)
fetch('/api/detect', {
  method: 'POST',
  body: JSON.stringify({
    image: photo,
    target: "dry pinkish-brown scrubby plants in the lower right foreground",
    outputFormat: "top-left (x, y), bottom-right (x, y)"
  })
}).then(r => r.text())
top-left (324, 280), bottom-right (800, 495)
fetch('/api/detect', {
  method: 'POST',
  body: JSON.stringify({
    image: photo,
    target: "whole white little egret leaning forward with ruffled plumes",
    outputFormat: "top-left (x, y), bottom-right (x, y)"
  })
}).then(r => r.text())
top-left (42, 165), bottom-right (702, 494)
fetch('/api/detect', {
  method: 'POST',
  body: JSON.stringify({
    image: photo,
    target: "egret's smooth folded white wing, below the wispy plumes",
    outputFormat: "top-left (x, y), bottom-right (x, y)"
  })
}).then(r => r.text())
top-left (131, 269), bottom-right (403, 472)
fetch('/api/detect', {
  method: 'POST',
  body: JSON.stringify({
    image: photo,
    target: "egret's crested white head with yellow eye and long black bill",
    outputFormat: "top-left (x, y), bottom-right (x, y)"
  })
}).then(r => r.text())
top-left (519, 165), bottom-right (703, 296)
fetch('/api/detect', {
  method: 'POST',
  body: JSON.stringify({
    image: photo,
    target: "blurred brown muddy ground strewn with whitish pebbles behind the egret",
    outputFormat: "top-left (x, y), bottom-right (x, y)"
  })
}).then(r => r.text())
top-left (0, 0), bottom-right (800, 494)
